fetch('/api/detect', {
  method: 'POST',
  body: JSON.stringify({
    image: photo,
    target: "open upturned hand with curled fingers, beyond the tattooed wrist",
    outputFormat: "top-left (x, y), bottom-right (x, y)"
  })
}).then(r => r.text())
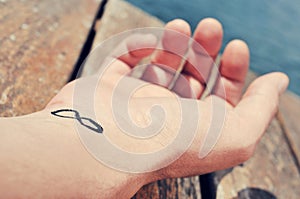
top-left (46, 19), bottom-right (288, 195)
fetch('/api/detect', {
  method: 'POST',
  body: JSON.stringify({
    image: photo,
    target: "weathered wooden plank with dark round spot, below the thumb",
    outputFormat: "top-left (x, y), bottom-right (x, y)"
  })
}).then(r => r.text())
top-left (214, 73), bottom-right (300, 198)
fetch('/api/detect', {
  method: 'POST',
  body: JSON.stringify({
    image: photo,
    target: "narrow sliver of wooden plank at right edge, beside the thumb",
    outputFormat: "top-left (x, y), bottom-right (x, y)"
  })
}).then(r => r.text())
top-left (279, 92), bottom-right (300, 166)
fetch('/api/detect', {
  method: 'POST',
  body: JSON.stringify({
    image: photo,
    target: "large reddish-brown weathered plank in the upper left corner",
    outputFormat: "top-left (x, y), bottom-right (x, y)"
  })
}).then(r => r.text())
top-left (0, 0), bottom-right (98, 116)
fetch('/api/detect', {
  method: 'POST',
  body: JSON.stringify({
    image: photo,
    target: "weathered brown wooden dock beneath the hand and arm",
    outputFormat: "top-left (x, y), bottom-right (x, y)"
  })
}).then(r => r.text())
top-left (0, 0), bottom-right (300, 199)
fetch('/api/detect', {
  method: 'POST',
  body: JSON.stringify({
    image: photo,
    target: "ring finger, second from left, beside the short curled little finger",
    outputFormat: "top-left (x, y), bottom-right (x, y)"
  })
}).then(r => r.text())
top-left (142, 19), bottom-right (191, 87)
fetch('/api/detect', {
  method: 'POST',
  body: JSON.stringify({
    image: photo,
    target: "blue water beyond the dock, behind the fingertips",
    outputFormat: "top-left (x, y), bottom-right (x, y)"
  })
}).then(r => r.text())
top-left (127, 0), bottom-right (300, 95)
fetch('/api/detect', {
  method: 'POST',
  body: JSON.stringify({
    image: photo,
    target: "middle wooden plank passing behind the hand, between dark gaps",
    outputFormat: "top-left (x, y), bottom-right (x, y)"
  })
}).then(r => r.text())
top-left (83, 0), bottom-right (201, 199)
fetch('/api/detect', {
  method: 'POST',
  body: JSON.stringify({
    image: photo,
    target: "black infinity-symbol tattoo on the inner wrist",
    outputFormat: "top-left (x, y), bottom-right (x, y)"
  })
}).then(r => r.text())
top-left (51, 109), bottom-right (103, 133)
